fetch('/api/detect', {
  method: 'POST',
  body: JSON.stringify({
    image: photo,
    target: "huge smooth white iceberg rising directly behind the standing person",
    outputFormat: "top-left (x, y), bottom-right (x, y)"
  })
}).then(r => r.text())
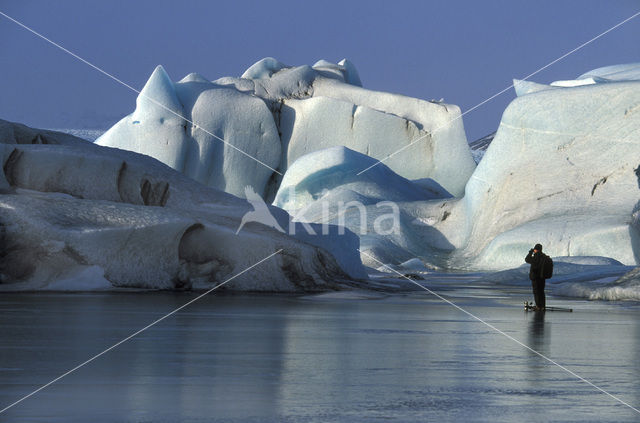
top-left (424, 74), bottom-right (640, 269)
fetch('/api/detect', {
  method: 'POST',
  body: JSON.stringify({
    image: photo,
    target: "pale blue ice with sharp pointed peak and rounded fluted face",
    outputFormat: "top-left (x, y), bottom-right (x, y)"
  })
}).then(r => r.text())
top-left (96, 66), bottom-right (281, 200)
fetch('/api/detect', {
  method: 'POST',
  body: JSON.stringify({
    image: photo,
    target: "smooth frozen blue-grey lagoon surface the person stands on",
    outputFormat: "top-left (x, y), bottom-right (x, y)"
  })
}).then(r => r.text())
top-left (0, 275), bottom-right (640, 423)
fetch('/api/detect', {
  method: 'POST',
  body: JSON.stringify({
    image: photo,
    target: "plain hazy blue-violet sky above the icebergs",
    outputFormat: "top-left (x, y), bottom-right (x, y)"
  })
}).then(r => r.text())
top-left (0, 0), bottom-right (640, 141)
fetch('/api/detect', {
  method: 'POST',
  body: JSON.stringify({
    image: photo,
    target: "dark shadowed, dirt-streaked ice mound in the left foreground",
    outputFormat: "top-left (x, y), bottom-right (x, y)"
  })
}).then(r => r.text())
top-left (0, 121), bottom-right (366, 291)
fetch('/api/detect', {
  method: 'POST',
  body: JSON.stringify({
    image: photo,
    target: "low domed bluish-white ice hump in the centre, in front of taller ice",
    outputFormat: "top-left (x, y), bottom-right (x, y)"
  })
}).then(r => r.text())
top-left (274, 147), bottom-right (451, 268)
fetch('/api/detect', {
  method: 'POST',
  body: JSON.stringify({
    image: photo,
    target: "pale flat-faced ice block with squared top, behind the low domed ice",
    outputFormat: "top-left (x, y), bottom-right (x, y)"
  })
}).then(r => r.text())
top-left (310, 79), bottom-right (475, 196)
